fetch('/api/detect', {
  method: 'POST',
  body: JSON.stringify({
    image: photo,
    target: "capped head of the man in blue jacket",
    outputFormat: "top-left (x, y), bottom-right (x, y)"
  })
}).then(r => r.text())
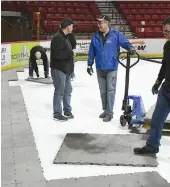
top-left (97, 16), bottom-right (111, 33)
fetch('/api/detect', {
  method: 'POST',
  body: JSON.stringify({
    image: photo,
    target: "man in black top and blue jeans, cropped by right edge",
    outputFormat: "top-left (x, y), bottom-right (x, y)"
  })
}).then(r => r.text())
top-left (134, 16), bottom-right (170, 154)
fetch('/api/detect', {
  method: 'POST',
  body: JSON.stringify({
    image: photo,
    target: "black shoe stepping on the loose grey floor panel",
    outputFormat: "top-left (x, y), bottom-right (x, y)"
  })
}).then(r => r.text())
top-left (133, 145), bottom-right (159, 155)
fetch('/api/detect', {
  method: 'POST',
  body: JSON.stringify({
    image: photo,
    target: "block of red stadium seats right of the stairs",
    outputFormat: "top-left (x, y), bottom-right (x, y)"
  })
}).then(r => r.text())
top-left (117, 1), bottom-right (170, 38)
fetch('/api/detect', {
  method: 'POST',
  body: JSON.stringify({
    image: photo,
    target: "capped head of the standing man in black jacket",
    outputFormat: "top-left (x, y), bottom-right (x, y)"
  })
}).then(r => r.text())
top-left (61, 18), bottom-right (75, 34)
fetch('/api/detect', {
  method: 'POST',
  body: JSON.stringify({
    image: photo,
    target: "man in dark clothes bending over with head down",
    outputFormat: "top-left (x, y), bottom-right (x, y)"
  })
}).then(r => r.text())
top-left (29, 46), bottom-right (49, 78)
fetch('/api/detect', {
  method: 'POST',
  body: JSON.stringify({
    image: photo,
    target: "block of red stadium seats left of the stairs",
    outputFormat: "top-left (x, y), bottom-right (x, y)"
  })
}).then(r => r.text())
top-left (2, 1), bottom-right (101, 34)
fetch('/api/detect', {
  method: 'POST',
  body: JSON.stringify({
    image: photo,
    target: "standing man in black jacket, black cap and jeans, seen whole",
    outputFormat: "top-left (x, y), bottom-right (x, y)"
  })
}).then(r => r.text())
top-left (50, 19), bottom-right (74, 121)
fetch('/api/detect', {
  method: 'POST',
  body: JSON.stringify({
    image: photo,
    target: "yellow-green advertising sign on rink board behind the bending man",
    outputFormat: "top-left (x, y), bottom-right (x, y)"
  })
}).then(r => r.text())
top-left (11, 42), bottom-right (40, 66)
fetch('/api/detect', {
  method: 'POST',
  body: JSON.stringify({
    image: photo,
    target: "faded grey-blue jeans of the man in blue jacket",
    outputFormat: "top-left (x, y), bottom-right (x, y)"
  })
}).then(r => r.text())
top-left (97, 70), bottom-right (117, 116)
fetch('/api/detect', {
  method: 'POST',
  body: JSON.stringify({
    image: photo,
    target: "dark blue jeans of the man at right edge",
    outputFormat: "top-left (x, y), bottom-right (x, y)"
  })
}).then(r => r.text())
top-left (147, 88), bottom-right (170, 149)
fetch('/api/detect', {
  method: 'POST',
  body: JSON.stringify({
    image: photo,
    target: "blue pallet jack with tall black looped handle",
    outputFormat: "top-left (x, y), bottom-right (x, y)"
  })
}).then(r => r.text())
top-left (118, 52), bottom-right (170, 131)
